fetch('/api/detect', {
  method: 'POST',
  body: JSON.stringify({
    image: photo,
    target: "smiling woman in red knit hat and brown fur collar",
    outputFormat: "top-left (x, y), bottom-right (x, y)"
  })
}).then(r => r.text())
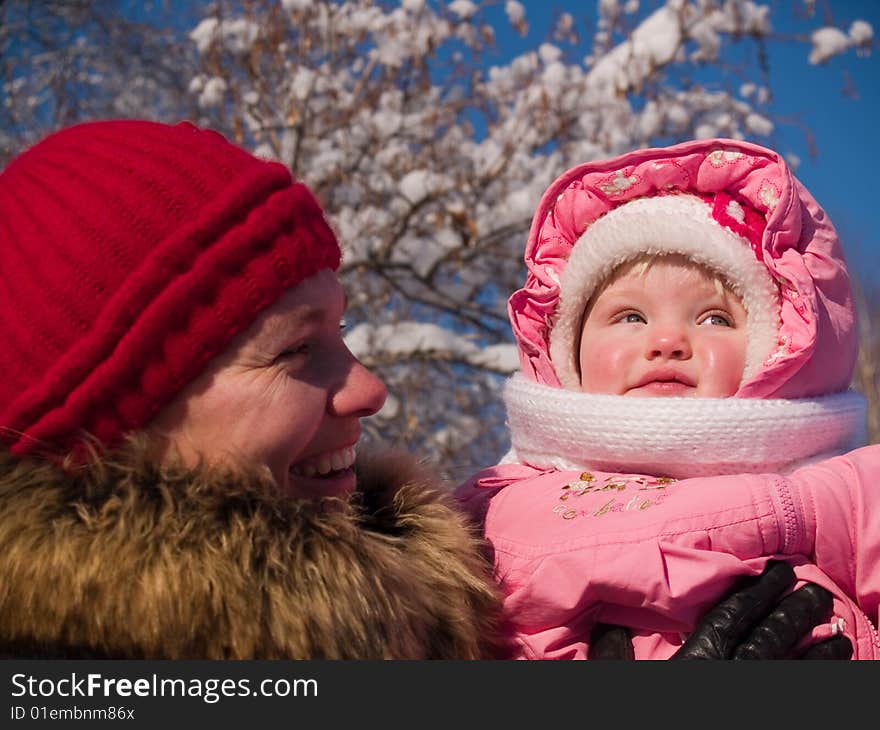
top-left (0, 121), bottom-right (848, 659)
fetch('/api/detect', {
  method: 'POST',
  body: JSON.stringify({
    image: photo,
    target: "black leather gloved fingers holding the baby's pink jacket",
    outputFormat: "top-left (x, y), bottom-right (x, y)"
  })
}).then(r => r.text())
top-left (588, 561), bottom-right (853, 659)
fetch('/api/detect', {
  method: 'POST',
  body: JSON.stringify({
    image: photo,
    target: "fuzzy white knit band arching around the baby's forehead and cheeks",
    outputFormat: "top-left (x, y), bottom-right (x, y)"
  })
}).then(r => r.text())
top-left (550, 194), bottom-right (780, 390)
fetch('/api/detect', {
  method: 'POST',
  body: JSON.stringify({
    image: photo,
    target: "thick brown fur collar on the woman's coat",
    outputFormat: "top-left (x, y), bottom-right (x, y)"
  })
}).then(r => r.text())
top-left (0, 439), bottom-right (501, 659)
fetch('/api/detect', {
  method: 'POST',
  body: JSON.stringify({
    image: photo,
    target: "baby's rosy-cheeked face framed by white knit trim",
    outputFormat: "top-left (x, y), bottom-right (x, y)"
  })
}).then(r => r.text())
top-left (579, 261), bottom-right (747, 398)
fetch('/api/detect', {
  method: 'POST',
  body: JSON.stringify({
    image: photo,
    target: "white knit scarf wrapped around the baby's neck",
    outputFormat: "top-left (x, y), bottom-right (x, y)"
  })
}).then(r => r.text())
top-left (502, 374), bottom-right (866, 479)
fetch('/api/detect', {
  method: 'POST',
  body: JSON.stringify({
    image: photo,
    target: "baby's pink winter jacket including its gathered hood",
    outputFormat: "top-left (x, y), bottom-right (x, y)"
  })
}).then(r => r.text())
top-left (457, 140), bottom-right (880, 659)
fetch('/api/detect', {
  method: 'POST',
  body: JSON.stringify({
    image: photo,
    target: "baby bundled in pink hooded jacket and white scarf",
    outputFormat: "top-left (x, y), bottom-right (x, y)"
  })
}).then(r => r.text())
top-left (458, 140), bottom-right (880, 659)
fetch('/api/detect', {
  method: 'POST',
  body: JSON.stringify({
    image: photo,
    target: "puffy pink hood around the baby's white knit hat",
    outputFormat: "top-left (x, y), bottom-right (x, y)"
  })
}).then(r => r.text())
top-left (508, 139), bottom-right (858, 398)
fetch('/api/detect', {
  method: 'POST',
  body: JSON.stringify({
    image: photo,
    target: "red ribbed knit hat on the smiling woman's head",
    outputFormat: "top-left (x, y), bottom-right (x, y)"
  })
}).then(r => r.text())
top-left (0, 121), bottom-right (340, 454)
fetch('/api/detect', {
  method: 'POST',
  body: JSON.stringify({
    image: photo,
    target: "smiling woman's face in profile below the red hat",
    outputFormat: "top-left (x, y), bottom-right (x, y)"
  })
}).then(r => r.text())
top-left (153, 269), bottom-right (386, 498)
